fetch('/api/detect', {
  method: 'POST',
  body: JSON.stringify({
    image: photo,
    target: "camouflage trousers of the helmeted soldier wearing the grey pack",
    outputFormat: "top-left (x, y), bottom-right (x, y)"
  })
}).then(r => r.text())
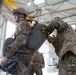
top-left (13, 50), bottom-right (32, 75)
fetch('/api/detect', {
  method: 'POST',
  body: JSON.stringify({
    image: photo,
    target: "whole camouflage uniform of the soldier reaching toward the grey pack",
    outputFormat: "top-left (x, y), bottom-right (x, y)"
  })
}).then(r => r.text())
top-left (46, 17), bottom-right (76, 75)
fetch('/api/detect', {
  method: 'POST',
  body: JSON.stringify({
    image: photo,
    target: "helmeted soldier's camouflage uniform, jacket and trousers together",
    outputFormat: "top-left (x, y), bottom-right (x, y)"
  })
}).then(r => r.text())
top-left (6, 20), bottom-right (32, 75)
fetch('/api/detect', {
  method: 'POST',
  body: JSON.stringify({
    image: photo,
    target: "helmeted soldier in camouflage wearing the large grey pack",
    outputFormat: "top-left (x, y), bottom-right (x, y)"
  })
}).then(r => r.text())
top-left (1, 8), bottom-right (32, 75)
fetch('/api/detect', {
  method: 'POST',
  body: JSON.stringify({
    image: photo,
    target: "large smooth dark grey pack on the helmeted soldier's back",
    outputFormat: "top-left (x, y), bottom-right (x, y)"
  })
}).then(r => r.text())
top-left (27, 24), bottom-right (46, 51)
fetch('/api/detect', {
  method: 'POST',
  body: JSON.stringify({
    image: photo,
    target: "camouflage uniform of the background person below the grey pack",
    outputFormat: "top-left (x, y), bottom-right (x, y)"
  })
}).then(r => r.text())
top-left (30, 52), bottom-right (45, 75)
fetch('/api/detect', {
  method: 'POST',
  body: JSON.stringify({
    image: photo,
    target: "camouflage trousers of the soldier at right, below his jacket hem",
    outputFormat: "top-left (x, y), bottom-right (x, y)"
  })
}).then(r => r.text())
top-left (59, 52), bottom-right (76, 75)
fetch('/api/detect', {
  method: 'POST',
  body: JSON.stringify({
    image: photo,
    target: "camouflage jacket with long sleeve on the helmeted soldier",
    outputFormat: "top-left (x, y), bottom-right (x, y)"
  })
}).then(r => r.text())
top-left (6, 20), bottom-right (31, 58)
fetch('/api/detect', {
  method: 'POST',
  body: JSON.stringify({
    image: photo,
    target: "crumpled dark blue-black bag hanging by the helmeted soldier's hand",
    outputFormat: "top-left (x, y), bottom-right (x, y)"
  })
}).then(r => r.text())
top-left (2, 55), bottom-right (19, 74)
